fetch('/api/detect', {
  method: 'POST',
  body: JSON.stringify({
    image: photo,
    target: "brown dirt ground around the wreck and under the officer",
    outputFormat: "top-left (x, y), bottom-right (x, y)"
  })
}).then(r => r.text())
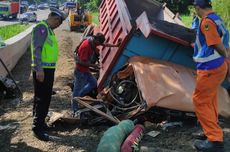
top-left (0, 22), bottom-right (230, 152)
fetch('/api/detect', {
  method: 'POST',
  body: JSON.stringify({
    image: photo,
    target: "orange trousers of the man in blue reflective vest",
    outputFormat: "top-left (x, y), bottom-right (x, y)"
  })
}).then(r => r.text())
top-left (193, 63), bottom-right (227, 141)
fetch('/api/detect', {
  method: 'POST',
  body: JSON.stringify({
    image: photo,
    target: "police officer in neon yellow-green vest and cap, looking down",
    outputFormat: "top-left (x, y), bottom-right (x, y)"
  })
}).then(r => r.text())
top-left (31, 8), bottom-right (66, 141)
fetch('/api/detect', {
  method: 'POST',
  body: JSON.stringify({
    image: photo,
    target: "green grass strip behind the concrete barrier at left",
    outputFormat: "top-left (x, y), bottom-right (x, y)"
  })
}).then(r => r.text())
top-left (0, 24), bottom-right (30, 40)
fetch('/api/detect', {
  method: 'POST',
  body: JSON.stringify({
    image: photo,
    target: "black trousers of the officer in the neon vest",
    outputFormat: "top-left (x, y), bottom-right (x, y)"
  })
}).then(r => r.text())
top-left (32, 69), bottom-right (55, 131)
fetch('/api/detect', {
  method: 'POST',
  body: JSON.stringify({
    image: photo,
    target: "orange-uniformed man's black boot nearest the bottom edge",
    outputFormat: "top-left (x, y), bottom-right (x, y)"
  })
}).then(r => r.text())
top-left (194, 140), bottom-right (224, 152)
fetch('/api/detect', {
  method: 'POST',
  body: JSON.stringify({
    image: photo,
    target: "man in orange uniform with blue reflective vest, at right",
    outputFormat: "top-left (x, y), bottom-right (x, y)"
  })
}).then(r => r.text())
top-left (193, 0), bottom-right (229, 152)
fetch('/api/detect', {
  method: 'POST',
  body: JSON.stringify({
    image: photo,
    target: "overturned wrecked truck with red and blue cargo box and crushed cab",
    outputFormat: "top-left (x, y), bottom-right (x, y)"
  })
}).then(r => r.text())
top-left (70, 0), bottom-right (230, 123)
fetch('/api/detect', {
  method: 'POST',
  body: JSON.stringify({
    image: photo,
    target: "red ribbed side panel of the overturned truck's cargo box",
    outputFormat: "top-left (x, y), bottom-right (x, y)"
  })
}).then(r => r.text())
top-left (98, 0), bottom-right (132, 88)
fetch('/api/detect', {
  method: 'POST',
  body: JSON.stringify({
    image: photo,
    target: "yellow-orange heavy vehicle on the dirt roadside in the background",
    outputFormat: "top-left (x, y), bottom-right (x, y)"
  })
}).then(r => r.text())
top-left (69, 9), bottom-right (92, 32)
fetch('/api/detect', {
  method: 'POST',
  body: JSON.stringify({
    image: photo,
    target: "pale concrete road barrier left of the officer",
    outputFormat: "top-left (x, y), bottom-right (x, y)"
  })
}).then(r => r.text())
top-left (0, 25), bottom-right (35, 77)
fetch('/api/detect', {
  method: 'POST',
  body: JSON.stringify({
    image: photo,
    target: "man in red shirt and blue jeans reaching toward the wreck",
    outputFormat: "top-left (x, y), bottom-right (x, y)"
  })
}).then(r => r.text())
top-left (71, 33), bottom-right (120, 116)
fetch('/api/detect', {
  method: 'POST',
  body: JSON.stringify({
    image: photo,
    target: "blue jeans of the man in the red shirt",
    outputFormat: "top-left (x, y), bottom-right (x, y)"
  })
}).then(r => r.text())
top-left (71, 70), bottom-right (97, 112)
